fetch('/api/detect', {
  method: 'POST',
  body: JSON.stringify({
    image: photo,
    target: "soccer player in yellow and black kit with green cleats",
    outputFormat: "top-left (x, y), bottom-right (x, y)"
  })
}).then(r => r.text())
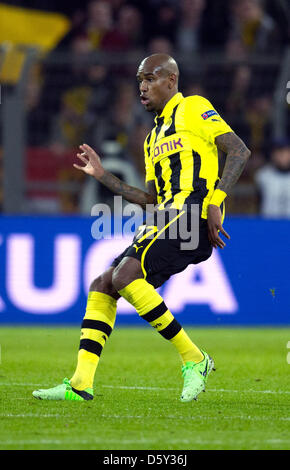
top-left (33, 54), bottom-right (250, 402)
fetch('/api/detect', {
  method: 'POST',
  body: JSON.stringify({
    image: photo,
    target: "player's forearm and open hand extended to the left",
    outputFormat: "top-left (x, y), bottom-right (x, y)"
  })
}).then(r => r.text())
top-left (73, 144), bottom-right (157, 209)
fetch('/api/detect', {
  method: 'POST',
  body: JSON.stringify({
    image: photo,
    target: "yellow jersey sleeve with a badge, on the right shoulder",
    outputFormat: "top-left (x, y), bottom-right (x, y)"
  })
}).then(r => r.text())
top-left (185, 95), bottom-right (234, 143)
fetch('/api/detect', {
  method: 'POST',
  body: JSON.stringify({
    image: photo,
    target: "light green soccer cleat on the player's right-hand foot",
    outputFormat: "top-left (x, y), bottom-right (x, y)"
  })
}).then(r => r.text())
top-left (180, 351), bottom-right (215, 403)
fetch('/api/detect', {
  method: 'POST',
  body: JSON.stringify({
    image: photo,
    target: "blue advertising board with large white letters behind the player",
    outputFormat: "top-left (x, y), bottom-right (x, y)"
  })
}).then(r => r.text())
top-left (0, 216), bottom-right (290, 326)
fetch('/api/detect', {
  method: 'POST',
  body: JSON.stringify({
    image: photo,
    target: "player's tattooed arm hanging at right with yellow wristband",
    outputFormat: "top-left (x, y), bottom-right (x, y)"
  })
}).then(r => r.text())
top-left (207, 132), bottom-right (251, 248)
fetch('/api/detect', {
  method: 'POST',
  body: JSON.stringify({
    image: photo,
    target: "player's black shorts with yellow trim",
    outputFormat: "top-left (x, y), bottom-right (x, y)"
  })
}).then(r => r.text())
top-left (112, 211), bottom-right (212, 288)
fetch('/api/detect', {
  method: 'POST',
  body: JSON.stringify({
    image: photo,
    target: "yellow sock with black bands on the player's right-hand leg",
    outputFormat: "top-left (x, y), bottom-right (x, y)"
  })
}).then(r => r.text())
top-left (119, 279), bottom-right (204, 363)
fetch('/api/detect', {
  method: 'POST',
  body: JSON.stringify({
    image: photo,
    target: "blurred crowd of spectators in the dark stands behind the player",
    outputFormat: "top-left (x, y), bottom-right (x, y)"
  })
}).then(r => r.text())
top-left (0, 0), bottom-right (290, 217)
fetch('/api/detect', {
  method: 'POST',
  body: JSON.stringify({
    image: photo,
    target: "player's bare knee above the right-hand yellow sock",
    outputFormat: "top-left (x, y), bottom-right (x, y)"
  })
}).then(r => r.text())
top-left (112, 258), bottom-right (144, 291)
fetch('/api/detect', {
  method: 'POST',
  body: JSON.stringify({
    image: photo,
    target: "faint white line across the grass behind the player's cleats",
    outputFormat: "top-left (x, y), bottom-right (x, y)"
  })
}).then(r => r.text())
top-left (0, 382), bottom-right (290, 395)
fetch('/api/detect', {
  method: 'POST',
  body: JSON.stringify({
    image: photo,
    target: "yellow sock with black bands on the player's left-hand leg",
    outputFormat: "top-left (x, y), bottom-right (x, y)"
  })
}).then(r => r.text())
top-left (70, 292), bottom-right (117, 390)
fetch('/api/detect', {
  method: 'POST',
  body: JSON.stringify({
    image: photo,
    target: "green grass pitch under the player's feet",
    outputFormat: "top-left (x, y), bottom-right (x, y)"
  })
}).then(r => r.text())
top-left (0, 327), bottom-right (290, 450)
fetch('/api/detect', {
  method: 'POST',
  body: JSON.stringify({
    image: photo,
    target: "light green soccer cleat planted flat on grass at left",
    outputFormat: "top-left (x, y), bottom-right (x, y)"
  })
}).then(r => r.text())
top-left (32, 379), bottom-right (94, 401)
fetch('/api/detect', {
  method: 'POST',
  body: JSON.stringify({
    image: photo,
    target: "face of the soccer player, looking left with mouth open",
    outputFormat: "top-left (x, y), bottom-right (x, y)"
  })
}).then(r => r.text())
top-left (137, 62), bottom-right (170, 114)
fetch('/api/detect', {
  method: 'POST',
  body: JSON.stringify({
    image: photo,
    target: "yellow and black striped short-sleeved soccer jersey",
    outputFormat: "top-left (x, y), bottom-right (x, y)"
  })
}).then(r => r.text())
top-left (144, 93), bottom-right (233, 219)
